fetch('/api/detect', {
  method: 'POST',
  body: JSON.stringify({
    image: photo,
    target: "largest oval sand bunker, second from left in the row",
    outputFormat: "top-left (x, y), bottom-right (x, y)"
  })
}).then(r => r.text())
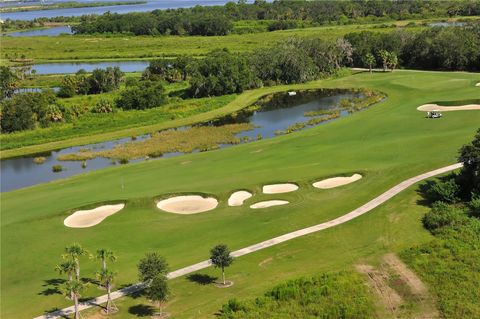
top-left (157, 195), bottom-right (218, 215)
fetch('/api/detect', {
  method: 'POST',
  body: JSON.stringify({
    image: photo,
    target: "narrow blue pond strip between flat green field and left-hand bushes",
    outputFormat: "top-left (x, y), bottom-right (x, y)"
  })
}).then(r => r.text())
top-left (26, 60), bottom-right (150, 74)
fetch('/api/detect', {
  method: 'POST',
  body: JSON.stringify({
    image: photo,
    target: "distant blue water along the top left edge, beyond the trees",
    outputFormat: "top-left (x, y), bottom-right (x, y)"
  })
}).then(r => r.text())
top-left (1, 0), bottom-right (253, 20)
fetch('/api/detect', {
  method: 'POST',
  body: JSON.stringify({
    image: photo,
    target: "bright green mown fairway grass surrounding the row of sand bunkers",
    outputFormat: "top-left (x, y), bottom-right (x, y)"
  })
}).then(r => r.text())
top-left (0, 71), bottom-right (480, 318)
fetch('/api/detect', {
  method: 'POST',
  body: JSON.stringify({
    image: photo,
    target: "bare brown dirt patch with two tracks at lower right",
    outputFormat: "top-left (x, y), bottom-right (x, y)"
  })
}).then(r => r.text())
top-left (356, 254), bottom-right (439, 319)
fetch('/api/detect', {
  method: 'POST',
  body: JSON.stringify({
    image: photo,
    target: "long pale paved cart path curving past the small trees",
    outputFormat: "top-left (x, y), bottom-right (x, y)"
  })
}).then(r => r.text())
top-left (35, 163), bottom-right (463, 319)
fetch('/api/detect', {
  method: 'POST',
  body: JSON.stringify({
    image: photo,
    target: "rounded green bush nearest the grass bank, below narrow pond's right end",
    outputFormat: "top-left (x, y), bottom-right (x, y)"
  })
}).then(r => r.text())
top-left (115, 81), bottom-right (167, 110)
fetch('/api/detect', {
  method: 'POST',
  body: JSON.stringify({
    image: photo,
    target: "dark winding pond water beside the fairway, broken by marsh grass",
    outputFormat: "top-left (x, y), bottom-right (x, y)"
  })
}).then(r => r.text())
top-left (0, 90), bottom-right (359, 192)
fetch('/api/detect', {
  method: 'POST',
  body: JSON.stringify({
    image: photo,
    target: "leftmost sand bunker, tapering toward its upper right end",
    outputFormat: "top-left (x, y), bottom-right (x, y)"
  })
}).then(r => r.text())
top-left (63, 204), bottom-right (125, 228)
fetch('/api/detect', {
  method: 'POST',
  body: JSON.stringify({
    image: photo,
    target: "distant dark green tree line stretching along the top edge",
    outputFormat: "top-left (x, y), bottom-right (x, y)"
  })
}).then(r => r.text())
top-left (73, 0), bottom-right (480, 36)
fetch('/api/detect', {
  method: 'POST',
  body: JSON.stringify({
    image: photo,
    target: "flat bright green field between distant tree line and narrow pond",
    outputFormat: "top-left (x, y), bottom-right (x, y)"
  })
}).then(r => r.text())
top-left (0, 25), bottom-right (422, 64)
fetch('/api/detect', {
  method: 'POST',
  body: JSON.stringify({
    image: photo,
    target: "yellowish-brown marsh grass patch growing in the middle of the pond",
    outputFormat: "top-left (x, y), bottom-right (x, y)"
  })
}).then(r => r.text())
top-left (58, 123), bottom-right (253, 164)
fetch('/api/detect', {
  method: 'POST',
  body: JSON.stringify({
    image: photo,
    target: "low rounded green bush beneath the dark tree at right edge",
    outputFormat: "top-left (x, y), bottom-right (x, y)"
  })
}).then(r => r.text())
top-left (422, 202), bottom-right (466, 232)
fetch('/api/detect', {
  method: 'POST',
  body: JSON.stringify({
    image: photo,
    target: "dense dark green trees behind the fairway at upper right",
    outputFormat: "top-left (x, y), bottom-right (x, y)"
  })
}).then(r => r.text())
top-left (345, 23), bottom-right (480, 71)
